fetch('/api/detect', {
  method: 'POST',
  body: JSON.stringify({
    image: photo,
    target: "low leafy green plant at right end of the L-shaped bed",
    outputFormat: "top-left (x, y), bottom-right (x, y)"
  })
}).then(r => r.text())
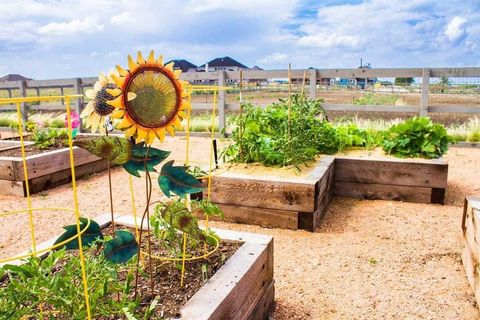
top-left (383, 117), bottom-right (453, 159)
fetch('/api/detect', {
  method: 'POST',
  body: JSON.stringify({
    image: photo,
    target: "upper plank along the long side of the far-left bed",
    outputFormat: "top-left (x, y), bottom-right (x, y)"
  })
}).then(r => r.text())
top-left (15, 147), bottom-right (100, 180)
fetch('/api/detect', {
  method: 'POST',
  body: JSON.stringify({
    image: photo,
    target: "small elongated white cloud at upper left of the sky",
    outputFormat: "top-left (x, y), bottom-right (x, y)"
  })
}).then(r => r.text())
top-left (38, 17), bottom-right (103, 36)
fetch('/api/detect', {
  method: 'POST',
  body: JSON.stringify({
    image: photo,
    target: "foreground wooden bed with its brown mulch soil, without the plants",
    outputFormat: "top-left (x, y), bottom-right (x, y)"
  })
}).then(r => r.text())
top-left (0, 214), bottom-right (274, 320)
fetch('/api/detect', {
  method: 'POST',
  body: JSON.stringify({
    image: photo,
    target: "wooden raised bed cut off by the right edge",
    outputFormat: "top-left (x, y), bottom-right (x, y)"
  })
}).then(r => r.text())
top-left (461, 197), bottom-right (480, 305)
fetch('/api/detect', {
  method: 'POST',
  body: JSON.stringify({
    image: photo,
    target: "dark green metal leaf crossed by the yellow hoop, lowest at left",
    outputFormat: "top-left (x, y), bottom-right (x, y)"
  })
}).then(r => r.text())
top-left (54, 218), bottom-right (103, 250)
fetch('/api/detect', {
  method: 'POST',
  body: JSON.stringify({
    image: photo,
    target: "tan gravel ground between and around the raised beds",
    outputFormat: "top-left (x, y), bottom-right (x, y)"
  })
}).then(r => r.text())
top-left (0, 138), bottom-right (480, 320)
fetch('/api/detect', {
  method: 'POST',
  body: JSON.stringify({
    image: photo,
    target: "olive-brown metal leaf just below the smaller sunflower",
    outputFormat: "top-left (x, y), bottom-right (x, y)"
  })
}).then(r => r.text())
top-left (74, 136), bottom-right (132, 164)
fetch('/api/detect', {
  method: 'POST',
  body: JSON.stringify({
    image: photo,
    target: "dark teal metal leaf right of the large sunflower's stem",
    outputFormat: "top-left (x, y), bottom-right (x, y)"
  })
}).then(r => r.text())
top-left (158, 160), bottom-right (205, 198)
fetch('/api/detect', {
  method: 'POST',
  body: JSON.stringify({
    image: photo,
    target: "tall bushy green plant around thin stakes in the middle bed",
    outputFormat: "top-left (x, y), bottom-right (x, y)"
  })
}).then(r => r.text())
top-left (222, 95), bottom-right (325, 166)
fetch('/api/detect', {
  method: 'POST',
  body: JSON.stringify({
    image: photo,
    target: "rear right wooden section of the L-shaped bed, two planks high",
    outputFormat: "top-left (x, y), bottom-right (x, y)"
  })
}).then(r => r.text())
top-left (335, 157), bottom-right (448, 204)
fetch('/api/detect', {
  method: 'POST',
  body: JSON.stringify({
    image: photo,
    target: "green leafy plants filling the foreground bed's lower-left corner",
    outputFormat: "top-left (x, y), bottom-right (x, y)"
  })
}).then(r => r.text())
top-left (0, 249), bottom-right (139, 320)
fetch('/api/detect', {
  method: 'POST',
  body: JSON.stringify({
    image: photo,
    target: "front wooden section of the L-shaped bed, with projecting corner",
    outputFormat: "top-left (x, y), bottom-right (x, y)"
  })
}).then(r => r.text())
top-left (204, 156), bottom-right (334, 231)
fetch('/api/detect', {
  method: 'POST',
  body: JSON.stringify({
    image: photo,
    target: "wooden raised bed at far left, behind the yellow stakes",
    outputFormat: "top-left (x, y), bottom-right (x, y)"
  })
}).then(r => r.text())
top-left (0, 147), bottom-right (107, 196)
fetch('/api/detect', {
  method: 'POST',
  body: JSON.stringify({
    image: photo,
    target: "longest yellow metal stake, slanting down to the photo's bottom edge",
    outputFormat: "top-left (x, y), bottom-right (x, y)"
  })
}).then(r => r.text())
top-left (65, 96), bottom-right (92, 320)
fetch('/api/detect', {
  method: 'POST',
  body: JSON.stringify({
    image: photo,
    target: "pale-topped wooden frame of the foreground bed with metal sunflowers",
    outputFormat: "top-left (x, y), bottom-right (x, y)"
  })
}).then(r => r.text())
top-left (1, 214), bottom-right (275, 320)
